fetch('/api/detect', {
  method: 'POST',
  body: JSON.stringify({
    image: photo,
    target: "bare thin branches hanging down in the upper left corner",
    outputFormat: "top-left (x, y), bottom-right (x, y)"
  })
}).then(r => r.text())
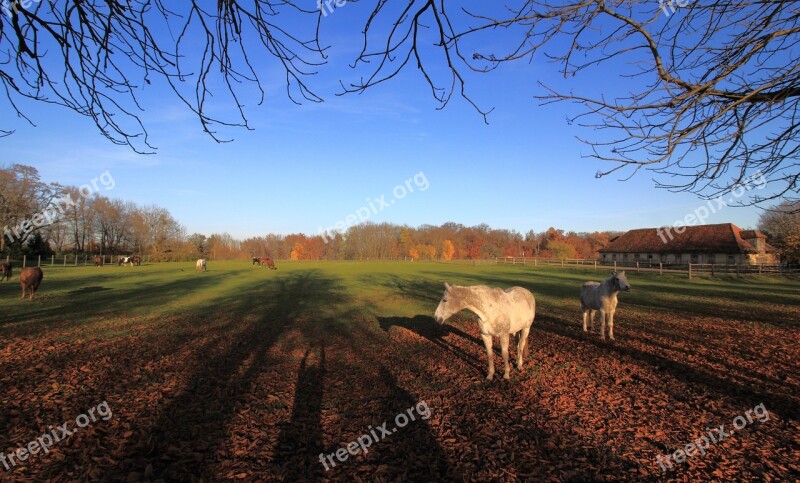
top-left (0, 0), bottom-right (324, 152)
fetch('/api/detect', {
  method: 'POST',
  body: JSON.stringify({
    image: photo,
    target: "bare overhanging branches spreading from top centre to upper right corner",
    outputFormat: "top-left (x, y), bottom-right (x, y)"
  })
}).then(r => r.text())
top-left (344, 0), bottom-right (800, 205)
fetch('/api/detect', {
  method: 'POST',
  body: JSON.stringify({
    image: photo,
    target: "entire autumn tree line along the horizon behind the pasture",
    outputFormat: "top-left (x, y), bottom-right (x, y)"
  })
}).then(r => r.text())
top-left (0, 164), bottom-right (800, 263)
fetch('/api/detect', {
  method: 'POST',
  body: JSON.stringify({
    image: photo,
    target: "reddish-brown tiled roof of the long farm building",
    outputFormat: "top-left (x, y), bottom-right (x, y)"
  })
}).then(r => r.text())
top-left (600, 223), bottom-right (772, 253)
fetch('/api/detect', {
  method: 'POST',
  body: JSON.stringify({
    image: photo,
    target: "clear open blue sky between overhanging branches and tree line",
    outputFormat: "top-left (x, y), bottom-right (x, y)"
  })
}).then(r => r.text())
top-left (0, 4), bottom-right (776, 238)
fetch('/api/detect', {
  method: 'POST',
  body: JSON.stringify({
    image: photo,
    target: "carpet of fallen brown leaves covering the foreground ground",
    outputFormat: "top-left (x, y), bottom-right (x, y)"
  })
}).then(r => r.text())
top-left (0, 296), bottom-right (800, 481)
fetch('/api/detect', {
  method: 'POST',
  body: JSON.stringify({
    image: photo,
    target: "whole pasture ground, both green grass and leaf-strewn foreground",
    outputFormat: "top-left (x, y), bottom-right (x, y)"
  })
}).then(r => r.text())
top-left (0, 262), bottom-right (800, 481)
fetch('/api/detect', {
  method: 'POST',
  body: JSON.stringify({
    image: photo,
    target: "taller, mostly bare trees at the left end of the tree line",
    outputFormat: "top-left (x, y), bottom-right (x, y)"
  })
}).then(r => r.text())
top-left (0, 164), bottom-right (187, 260)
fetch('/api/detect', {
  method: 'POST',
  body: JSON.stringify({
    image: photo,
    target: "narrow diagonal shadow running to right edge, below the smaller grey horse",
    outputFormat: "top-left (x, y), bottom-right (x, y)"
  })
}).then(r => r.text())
top-left (538, 316), bottom-right (800, 420)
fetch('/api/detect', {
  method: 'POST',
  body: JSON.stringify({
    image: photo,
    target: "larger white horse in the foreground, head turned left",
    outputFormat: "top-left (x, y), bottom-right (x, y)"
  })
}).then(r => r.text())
top-left (433, 283), bottom-right (536, 380)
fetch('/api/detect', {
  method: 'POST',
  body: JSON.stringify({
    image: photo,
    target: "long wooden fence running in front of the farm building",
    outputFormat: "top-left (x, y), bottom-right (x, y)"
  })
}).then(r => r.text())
top-left (495, 257), bottom-right (800, 278)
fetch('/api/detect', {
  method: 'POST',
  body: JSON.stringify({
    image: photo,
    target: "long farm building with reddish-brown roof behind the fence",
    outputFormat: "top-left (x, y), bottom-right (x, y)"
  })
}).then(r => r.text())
top-left (600, 223), bottom-right (776, 265)
